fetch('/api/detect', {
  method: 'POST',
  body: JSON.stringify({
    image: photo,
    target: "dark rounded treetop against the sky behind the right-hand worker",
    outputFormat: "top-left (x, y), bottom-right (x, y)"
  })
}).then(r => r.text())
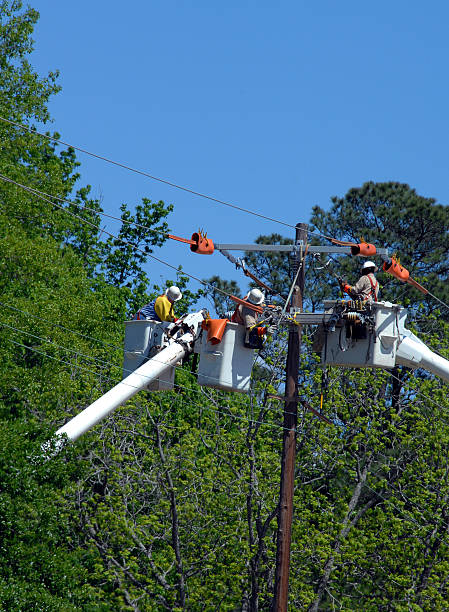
top-left (311, 182), bottom-right (449, 310)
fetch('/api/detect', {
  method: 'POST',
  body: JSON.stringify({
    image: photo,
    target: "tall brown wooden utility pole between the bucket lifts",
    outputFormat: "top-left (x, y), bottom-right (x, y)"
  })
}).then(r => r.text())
top-left (272, 223), bottom-right (308, 612)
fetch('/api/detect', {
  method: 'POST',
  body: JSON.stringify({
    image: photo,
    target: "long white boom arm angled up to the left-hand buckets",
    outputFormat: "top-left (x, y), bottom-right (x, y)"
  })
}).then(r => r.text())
top-left (42, 311), bottom-right (204, 456)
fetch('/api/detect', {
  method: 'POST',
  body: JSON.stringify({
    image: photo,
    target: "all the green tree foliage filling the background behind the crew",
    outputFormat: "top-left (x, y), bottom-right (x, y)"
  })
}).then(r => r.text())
top-left (0, 1), bottom-right (449, 612)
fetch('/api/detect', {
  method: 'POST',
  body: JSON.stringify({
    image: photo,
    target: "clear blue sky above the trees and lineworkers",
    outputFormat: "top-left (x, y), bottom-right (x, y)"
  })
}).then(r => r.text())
top-left (30, 0), bottom-right (449, 296)
